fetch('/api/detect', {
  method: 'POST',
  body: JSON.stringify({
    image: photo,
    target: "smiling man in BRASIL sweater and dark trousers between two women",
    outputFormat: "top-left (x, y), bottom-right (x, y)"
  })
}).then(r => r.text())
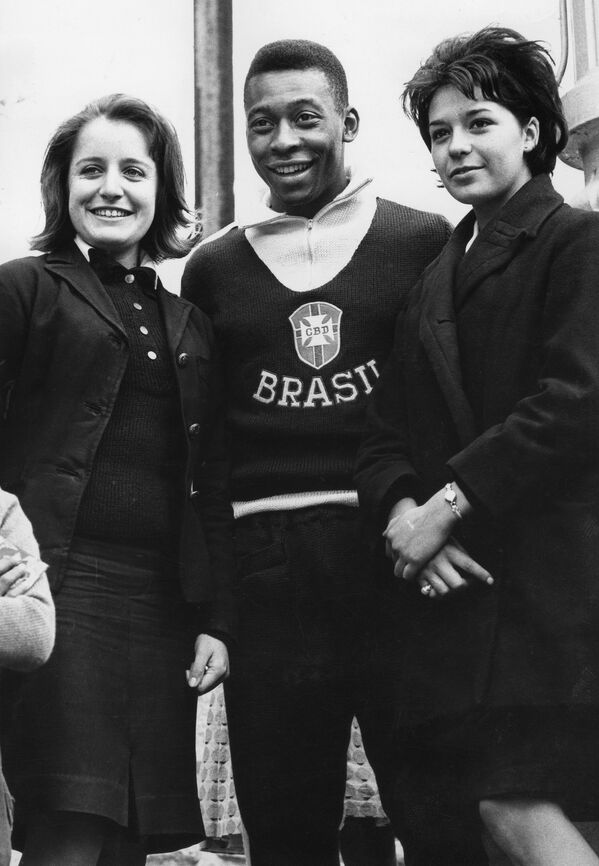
top-left (182, 40), bottom-right (449, 866)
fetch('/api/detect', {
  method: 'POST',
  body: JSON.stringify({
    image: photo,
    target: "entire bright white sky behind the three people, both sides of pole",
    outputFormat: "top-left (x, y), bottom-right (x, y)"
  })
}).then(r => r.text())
top-left (0, 0), bottom-right (582, 288)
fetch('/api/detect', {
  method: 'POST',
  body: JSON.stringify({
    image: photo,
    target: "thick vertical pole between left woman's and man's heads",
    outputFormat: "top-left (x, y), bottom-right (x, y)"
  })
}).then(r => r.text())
top-left (194, 0), bottom-right (234, 237)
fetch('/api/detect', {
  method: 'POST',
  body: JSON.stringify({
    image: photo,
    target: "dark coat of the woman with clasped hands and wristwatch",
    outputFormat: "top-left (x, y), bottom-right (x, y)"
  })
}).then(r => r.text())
top-left (357, 175), bottom-right (599, 719)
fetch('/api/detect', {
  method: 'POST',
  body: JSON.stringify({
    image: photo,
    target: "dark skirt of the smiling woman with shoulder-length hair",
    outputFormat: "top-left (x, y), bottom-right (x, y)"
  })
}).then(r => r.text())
top-left (9, 541), bottom-right (204, 853)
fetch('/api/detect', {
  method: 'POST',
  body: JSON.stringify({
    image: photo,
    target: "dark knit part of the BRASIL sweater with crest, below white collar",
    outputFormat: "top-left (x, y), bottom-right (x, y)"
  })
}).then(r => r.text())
top-left (182, 200), bottom-right (449, 501)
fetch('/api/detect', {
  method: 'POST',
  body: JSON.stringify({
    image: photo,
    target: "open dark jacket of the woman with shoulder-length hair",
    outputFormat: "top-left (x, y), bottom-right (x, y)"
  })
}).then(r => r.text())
top-left (0, 244), bottom-right (233, 638)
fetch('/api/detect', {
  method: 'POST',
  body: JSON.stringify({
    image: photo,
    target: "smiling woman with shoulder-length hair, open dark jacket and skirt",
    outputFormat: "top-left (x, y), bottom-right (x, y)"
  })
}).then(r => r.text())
top-left (0, 94), bottom-right (232, 866)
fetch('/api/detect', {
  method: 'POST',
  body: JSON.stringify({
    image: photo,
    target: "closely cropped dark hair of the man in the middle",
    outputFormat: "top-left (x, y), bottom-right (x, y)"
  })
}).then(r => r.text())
top-left (243, 39), bottom-right (349, 112)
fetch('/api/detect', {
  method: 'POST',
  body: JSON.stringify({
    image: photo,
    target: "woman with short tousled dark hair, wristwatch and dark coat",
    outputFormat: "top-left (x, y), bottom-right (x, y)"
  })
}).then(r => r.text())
top-left (357, 27), bottom-right (599, 866)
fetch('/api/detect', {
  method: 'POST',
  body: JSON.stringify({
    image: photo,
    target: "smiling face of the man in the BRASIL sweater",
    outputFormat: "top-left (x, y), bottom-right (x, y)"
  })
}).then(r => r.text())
top-left (245, 69), bottom-right (359, 218)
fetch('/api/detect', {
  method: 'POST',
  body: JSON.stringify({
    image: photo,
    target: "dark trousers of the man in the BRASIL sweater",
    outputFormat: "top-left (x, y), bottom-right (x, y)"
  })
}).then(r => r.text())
top-left (227, 505), bottom-right (404, 866)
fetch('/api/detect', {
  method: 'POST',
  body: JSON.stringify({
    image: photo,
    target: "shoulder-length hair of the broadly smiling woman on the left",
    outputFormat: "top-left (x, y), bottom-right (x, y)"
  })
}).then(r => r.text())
top-left (31, 93), bottom-right (199, 261)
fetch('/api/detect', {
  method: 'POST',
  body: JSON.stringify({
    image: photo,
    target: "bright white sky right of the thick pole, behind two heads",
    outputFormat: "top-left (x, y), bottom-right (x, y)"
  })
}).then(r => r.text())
top-left (233, 0), bottom-right (583, 222)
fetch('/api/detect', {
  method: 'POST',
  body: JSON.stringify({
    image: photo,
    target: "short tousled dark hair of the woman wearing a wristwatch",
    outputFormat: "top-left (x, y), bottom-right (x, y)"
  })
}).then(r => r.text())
top-left (402, 27), bottom-right (568, 175)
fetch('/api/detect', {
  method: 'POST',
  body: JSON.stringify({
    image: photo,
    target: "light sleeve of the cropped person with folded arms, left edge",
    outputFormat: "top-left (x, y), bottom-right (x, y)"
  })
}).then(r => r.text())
top-left (0, 489), bottom-right (54, 670)
